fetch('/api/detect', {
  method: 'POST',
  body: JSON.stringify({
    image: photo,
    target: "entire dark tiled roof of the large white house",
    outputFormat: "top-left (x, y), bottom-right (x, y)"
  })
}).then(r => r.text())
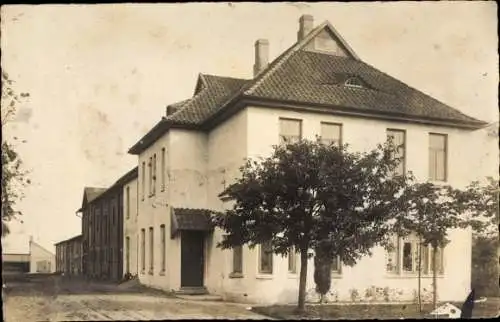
top-left (129, 22), bottom-right (486, 154)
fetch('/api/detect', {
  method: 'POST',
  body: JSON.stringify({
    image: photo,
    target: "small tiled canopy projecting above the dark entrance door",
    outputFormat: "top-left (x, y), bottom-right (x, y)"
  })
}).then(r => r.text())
top-left (170, 208), bottom-right (213, 238)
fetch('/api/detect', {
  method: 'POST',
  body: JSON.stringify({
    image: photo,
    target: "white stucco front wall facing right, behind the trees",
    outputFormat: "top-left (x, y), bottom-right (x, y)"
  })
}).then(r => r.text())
top-left (247, 107), bottom-right (480, 301)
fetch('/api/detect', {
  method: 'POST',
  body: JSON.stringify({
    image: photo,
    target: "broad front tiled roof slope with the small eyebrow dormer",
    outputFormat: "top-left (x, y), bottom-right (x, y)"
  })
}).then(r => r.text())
top-left (245, 50), bottom-right (478, 122)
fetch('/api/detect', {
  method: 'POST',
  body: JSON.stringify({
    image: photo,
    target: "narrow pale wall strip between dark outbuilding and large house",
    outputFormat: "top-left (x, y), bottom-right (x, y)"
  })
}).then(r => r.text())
top-left (123, 178), bottom-right (139, 275)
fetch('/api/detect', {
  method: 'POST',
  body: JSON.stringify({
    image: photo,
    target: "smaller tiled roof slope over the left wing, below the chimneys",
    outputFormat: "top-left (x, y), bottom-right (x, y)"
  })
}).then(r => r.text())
top-left (166, 74), bottom-right (249, 124)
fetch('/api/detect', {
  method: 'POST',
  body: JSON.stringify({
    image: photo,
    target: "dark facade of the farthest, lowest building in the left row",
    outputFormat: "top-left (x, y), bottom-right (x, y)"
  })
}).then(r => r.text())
top-left (55, 235), bottom-right (83, 275)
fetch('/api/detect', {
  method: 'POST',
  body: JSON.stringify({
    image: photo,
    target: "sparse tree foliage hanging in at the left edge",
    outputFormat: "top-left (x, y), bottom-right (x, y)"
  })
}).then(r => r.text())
top-left (2, 72), bottom-right (30, 237)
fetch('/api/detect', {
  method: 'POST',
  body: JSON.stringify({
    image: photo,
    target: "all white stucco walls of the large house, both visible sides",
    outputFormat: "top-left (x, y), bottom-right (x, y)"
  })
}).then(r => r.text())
top-left (133, 107), bottom-right (483, 304)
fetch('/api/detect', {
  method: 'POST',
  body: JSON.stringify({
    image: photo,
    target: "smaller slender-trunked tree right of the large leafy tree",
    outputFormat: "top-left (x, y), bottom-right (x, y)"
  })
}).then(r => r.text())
top-left (395, 182), bottom-right (480, 308)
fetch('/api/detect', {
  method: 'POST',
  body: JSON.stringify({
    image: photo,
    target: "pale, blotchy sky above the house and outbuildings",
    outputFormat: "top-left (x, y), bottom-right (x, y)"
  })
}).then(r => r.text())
top-left (1, 1), bottom-right (499, 252)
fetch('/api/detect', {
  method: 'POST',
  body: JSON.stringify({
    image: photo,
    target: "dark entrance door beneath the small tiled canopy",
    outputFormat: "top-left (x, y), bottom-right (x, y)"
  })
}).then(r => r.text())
top-left (181, 230), bottom-right (204, 287)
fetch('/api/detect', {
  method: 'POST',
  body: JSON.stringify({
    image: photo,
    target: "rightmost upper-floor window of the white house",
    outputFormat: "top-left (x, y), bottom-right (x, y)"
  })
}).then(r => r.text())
top-left (429, 133), bottom-right (447, 181)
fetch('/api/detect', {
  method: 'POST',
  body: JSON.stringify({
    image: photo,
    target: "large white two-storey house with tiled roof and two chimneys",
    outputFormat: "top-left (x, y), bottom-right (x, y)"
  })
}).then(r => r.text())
top-left (129, 15), bottom-right (485, 303)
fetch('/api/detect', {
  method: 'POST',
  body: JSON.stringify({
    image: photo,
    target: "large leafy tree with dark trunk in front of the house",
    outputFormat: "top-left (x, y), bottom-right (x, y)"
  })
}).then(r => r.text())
top-left (214, 140), bottom-right (407, 313)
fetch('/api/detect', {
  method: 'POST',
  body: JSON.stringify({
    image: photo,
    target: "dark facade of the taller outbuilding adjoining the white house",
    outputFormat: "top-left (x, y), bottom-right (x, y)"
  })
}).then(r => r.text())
top-left (78, 168), bottom-right (137, 281)
